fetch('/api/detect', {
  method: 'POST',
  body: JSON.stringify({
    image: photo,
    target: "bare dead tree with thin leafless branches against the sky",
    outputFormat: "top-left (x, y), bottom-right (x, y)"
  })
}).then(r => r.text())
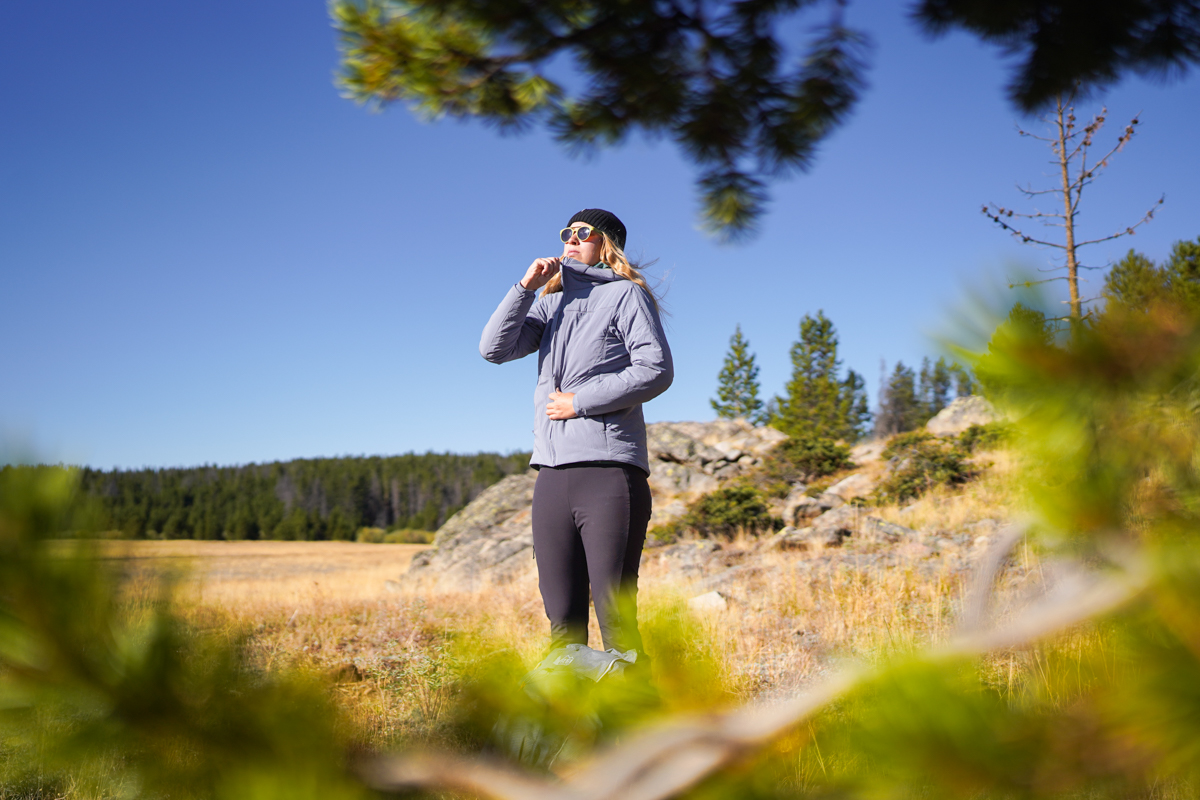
top-left (983, 91), bottom-right (1165, 321)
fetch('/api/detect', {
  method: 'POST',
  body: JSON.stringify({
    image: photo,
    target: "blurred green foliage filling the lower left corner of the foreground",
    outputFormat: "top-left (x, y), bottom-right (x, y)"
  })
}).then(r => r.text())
top-left (0, 468), bottom-right (365, 800)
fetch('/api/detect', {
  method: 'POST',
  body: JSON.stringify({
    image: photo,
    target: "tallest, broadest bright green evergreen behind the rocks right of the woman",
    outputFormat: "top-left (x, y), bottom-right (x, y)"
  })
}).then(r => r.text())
top-left (772, 311), bottom-right (870, 441)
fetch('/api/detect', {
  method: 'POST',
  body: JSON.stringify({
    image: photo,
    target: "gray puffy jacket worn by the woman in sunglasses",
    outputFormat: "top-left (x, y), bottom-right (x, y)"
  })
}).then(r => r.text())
top-left (479, 258), bottom-right (674, 473)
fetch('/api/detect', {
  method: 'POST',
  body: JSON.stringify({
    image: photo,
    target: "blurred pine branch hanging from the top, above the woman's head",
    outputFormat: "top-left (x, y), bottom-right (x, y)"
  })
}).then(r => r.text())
top-left (330, 0), bottom-right (865, 236)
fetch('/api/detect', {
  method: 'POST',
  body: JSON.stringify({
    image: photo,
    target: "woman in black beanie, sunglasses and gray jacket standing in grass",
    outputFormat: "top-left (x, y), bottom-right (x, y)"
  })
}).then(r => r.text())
top-left (479, 209), bottom-right (673, 652)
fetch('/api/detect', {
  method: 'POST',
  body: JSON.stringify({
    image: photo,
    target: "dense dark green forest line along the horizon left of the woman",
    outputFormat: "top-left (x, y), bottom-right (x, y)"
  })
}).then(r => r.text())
top-left (59, 453), bottom-right (529, 541)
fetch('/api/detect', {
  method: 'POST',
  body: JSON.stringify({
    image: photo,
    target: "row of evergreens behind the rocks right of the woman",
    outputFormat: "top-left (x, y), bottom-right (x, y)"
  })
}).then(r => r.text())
top-left (710, 311), bottom-right (977, 443)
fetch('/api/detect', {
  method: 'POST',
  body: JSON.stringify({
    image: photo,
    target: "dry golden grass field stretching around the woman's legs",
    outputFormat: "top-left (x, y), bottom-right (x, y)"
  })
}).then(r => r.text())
top-left (91, 455), bottom-right (1034, 747)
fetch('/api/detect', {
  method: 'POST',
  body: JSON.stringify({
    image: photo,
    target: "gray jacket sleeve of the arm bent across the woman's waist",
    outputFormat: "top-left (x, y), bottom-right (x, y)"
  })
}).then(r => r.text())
top-left (575, 287), bottom-right (674, 416)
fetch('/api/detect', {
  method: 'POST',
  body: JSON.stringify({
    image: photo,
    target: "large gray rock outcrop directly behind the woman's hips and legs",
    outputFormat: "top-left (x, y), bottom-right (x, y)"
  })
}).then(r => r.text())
top-left (404, 420), bottom-right (787, 589)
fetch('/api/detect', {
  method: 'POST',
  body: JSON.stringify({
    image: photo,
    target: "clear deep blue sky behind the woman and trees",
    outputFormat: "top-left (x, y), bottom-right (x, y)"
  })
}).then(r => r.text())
top-left (0, 0), bottom-right (1200, 468)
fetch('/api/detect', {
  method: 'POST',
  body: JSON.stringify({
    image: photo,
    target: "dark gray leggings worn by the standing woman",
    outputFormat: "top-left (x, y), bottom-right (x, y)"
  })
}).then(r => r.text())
top-left (533, 464), bottom-right (650, 651)
